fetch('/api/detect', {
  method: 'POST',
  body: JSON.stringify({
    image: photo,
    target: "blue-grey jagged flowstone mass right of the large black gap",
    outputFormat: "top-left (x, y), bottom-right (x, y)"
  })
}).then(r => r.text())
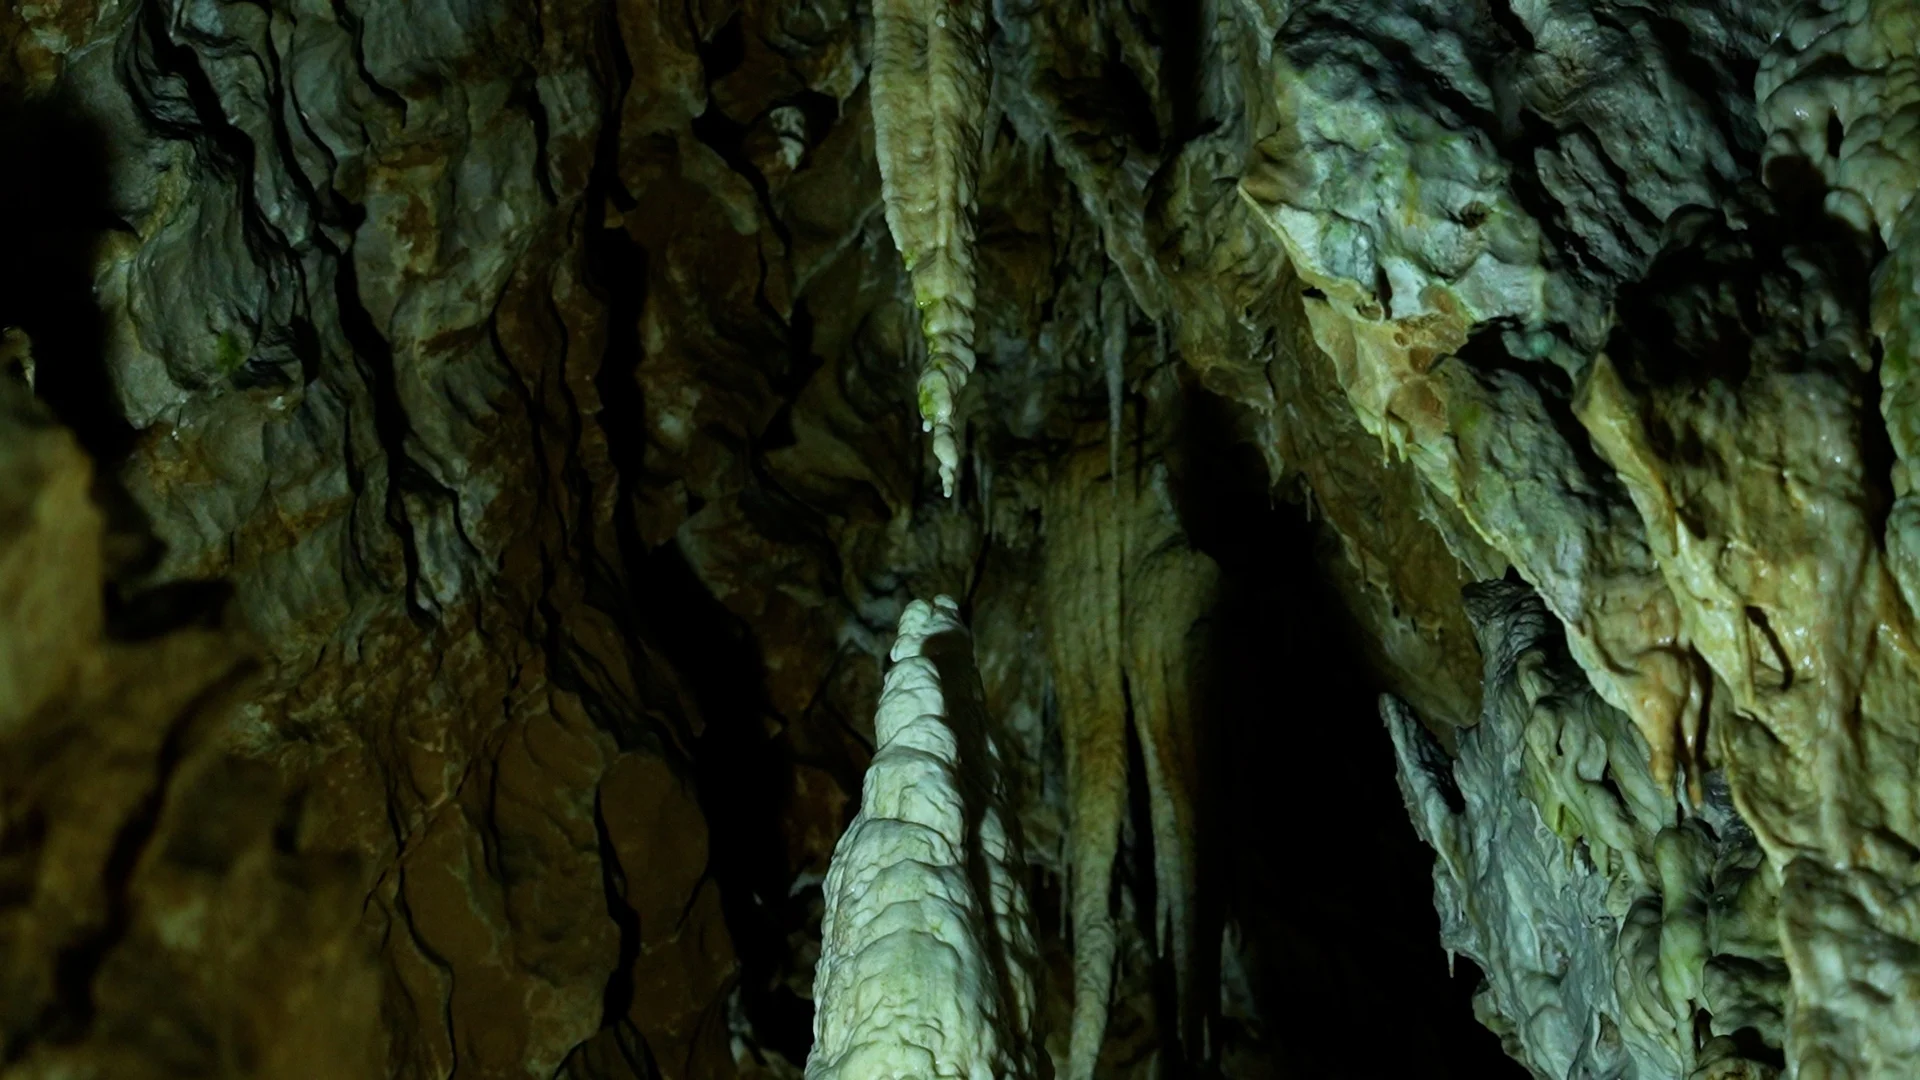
top-left (1380, 582), bottom-right (1788, 1080)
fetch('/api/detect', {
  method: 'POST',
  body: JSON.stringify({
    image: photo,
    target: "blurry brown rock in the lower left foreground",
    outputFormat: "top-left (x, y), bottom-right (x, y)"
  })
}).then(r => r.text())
top-left (0, 377), bottom-right (384, 1080)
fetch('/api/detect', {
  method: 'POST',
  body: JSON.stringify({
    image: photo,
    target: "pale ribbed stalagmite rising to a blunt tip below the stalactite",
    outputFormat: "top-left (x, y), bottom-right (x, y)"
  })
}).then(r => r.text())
top-left (806, 596), bottom-right (1037, 1080)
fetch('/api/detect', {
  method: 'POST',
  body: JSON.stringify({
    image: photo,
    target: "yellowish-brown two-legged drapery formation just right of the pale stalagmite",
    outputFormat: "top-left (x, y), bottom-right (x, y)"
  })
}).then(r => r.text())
top-left (1043, 432), bottom-right (1219, 1080)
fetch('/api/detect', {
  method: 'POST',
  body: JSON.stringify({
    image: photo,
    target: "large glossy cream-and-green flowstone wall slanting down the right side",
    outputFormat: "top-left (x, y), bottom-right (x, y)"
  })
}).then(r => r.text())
top-left (1213, 0), bottom-right (1920, 1076)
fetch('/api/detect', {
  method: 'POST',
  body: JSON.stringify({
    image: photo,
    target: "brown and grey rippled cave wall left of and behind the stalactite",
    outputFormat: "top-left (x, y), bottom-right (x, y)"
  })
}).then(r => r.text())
top-left (0, 4), bottom-right (1173, 1076)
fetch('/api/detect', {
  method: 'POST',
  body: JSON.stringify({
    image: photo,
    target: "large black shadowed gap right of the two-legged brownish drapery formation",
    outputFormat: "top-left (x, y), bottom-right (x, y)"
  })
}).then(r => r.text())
top-left (1183, 386), bottom-right (1526, 1080)
